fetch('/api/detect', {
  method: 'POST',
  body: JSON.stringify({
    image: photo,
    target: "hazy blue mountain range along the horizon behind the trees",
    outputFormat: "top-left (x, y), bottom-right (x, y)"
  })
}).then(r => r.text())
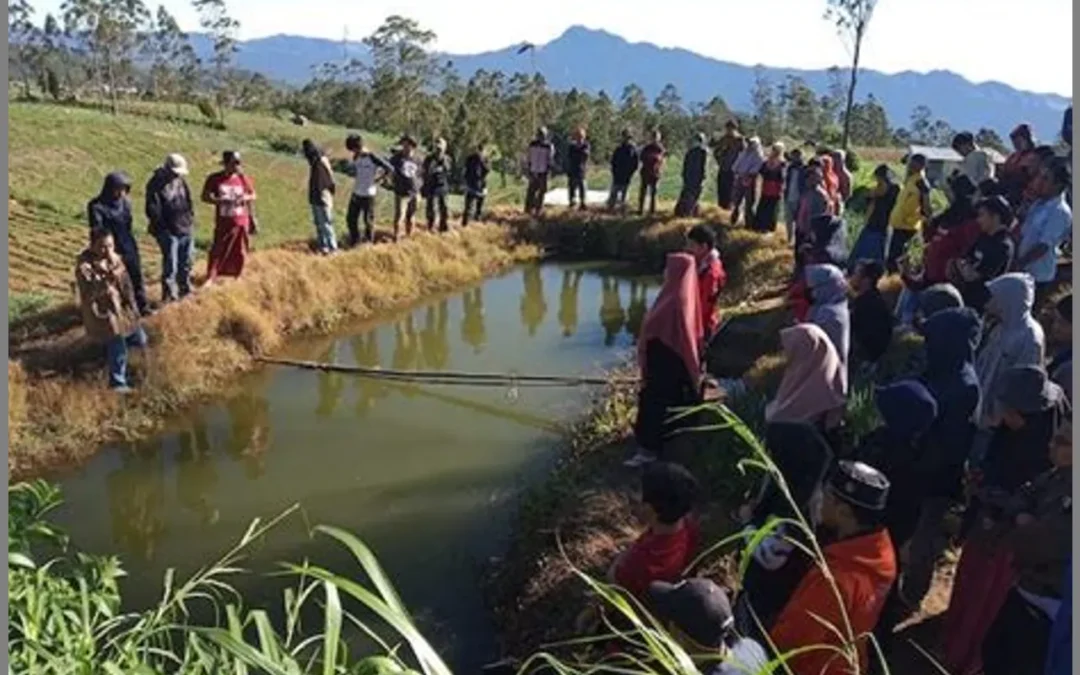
top-left (193, 26), bottom-right (1071, 140)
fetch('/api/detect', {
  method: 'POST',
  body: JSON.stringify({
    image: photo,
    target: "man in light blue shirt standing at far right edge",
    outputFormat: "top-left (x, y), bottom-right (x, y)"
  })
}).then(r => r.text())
top-left (1016, 159), bottom-right (1072, 304)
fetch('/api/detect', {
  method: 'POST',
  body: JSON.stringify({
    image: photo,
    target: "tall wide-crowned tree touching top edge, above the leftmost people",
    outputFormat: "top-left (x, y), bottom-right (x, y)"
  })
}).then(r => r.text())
top-left (60, 0), bottom-right (150, 114)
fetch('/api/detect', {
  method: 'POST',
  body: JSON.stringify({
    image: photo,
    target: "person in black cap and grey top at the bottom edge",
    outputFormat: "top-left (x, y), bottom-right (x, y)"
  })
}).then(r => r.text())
top-left (647, 579), bottom-right (769, 675)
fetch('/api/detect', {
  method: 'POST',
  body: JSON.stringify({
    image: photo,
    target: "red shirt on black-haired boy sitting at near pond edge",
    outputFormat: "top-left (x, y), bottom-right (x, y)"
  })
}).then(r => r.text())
top-left (615, 517), bottom-right (698, 598)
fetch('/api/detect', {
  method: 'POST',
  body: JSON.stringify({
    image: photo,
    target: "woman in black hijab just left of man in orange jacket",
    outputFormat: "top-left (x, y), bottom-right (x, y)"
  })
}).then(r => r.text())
top-left (735, 422), bottom-right (833, 640)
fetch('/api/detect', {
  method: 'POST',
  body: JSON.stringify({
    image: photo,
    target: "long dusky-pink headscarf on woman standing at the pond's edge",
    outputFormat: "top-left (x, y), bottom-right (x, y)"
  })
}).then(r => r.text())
top-left (637, 253), bottom-right (704, 378)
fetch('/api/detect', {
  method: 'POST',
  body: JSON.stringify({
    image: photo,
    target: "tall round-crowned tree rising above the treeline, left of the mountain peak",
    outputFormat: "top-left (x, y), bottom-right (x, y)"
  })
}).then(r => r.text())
top-left (364, 14), bottom-right (438, 130)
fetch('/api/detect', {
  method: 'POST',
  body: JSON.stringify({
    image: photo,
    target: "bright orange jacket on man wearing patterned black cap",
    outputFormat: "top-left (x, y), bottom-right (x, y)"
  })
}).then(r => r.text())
top-left (769, 528), bottom-right (896, 675)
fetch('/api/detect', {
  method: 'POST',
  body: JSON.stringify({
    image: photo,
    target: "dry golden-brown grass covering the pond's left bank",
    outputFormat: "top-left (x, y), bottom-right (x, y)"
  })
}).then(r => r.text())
top-left (8, 225), bottom-right (537, 480)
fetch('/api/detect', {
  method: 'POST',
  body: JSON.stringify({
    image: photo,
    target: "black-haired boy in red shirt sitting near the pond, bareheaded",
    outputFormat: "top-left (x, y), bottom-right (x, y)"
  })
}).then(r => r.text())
top-left (608, 461), bottom-right (698, 598)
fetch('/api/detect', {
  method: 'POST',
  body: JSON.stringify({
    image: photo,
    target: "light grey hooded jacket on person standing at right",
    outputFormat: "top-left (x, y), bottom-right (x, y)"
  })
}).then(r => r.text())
top-left (975, 273), bottom-right (1045, 421)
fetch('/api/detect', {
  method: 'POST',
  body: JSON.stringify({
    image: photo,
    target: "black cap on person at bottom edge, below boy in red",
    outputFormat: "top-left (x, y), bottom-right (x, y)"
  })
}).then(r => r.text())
top-left (648, 579), bottom-right (734, 649)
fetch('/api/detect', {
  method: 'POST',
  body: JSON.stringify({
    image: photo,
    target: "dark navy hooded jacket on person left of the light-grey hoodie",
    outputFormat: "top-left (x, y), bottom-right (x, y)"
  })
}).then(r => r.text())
top-left (922, 308), bottom-right (983, 497)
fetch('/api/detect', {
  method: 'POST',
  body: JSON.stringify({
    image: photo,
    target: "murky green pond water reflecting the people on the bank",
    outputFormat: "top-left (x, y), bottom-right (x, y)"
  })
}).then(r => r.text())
top-left (52, 259), bottom-right (654, 673)
